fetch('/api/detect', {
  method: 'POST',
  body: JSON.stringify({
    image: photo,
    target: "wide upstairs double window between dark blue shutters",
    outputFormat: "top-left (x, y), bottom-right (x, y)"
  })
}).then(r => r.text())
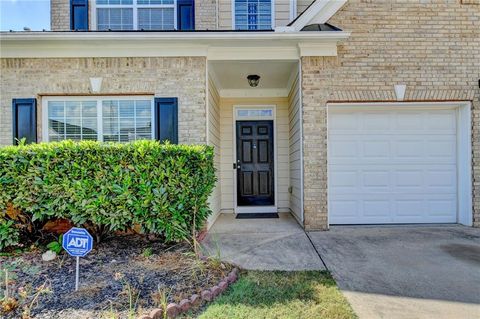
top-left (96, 0), bottom-right (177, 30)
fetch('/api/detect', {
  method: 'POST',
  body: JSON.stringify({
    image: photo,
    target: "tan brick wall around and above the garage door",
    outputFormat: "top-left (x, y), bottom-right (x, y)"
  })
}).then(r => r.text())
top-left (301, 0), bottom-right (480, 229)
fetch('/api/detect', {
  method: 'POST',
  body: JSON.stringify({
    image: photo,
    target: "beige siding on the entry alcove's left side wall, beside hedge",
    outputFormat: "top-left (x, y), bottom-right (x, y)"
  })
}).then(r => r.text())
top-left (207, 78), bottom-right (222, 226)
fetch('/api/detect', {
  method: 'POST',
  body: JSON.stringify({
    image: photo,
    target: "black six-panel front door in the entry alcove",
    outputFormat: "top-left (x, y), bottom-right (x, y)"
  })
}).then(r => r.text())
top-left (236, 121), bottom-right (275, 206)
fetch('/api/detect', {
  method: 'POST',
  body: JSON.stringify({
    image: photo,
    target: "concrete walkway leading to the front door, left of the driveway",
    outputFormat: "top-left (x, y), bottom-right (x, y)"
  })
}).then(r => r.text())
top-left (202, 213), bottom-right (325, 270)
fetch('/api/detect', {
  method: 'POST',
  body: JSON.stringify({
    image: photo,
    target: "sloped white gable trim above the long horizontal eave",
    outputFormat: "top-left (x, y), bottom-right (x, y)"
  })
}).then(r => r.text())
top-left (290, 0), bottom-right (347, 31)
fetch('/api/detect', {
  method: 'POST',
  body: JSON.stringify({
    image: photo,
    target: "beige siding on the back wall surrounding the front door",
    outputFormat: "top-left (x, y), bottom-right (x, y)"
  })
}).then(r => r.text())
top-left (220, 98), bottom-right (290, 211)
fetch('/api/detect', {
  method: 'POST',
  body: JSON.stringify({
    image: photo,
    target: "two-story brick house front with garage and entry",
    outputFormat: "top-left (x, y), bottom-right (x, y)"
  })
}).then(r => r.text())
top-left (0, 0), bottom-right (480, 230)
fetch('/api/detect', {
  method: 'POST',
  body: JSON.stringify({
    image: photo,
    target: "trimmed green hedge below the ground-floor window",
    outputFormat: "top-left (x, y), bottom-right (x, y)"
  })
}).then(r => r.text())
top-left (0, 141), bottom-right (215, 248)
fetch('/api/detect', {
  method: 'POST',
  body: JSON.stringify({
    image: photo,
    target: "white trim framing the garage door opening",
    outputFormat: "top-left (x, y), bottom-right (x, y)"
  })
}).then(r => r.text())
top-left (327, 101), bottom-right (473, 226)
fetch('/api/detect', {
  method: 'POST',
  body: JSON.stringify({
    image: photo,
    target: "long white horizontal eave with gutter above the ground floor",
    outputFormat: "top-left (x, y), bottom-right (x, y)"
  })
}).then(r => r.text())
top-left (0, 31), bottom-right (350, 60)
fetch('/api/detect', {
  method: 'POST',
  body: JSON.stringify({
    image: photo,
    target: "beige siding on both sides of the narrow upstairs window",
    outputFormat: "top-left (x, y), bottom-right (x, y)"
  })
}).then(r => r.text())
top-left (218, 0), bottom-right (290, 30)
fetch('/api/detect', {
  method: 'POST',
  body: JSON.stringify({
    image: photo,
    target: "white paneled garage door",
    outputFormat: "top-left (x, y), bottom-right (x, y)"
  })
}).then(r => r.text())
top-left (328, 109), bottom-right (457, 224)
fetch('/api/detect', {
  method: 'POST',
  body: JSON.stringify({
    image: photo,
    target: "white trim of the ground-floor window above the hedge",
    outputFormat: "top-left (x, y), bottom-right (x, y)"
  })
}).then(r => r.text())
top-left (42, 95), bottom-right (156, 142)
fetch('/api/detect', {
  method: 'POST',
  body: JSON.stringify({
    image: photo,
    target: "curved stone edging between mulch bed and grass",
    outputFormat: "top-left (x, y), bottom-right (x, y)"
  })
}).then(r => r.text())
top-left (137, 267), bottom-right (238, 319)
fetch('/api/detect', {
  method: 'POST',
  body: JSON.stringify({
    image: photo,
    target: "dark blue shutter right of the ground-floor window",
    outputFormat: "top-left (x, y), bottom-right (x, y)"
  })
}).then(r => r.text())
top-left (155, 97), bottom-right (178, 144)
